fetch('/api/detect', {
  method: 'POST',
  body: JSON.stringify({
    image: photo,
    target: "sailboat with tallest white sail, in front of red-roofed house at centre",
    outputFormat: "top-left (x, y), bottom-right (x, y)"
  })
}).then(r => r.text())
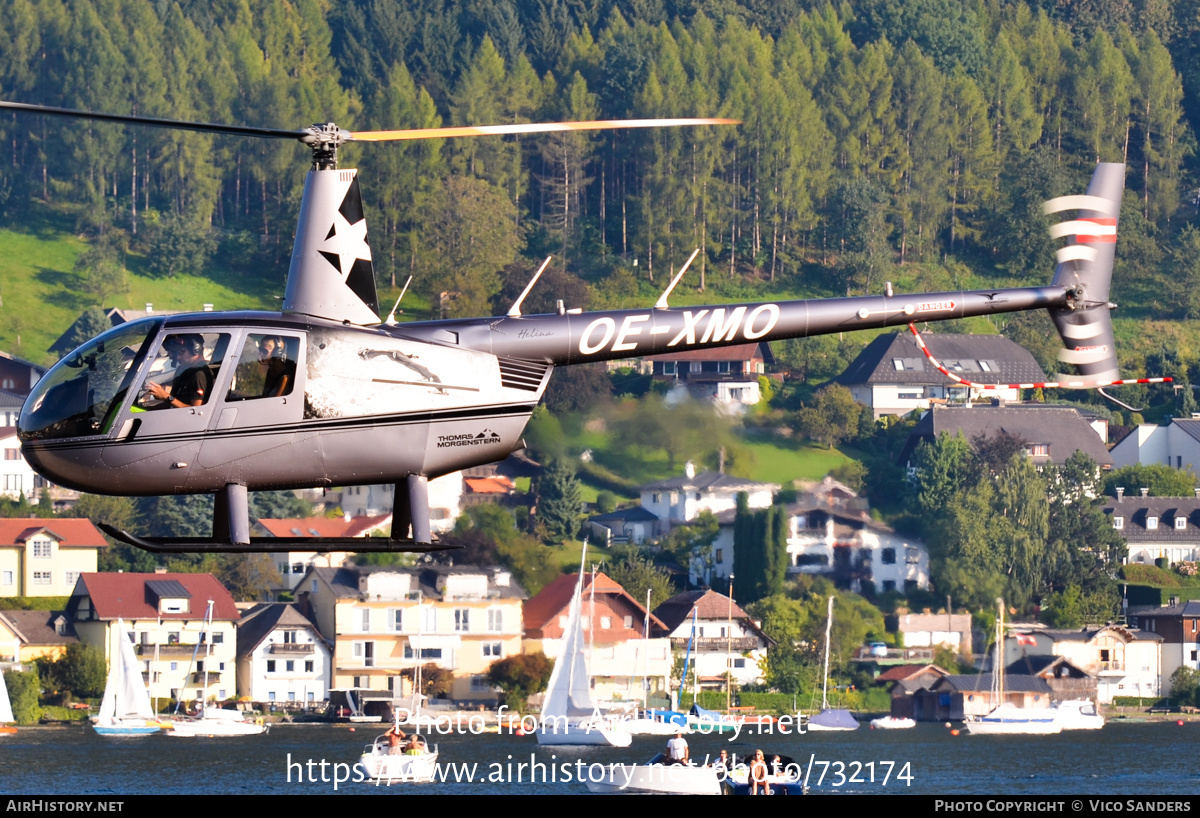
top-left (538, 540), bottom-right (634, 747)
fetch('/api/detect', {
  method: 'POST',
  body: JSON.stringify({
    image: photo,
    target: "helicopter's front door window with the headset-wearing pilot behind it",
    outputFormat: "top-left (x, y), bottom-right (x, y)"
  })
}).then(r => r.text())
top-left (133, 330), bottom-right (230, 411)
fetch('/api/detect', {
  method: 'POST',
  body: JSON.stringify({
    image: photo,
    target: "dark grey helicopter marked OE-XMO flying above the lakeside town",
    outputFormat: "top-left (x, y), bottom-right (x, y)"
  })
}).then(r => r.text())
top-left (7, 102), bottom-right (1144, 553)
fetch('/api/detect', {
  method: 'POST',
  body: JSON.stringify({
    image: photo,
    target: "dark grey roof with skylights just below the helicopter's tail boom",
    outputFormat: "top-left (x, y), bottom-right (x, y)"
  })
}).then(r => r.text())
top-left (834, 332), bottom-right (1049, 386)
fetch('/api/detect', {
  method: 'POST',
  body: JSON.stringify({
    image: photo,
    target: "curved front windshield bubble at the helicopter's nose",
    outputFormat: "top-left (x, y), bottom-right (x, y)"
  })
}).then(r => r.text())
top-left (17, 318), bottom-right (162, 440)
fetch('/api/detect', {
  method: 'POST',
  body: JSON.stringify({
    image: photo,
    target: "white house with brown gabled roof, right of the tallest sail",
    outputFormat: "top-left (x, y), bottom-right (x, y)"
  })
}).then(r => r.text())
top-left (654, 590), bottom-right (775, 690)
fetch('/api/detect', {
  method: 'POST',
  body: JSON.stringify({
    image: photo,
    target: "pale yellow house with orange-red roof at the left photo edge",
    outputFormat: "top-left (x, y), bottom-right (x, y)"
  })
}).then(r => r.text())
top-left (0, 517), bottom-right (108, 596)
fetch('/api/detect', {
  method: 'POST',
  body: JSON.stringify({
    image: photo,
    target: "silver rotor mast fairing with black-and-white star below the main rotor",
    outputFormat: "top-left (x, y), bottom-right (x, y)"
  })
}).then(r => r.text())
top-left (283, 169), bottom-right (379, 324)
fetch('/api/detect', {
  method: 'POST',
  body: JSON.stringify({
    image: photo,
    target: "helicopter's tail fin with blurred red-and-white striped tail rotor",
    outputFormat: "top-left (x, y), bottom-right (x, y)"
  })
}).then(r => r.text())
top-left (1045, 163), bottom-right (1123, 386)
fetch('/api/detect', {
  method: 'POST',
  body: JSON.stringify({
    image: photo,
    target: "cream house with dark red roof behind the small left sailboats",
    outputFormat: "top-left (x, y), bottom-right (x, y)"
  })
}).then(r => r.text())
top-left (67, 572), bottom-right (241, 702)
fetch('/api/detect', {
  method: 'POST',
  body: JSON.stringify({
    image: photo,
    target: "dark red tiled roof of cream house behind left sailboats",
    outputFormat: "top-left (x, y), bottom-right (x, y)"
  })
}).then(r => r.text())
top-left (79, 573), bottom-right (241, 621)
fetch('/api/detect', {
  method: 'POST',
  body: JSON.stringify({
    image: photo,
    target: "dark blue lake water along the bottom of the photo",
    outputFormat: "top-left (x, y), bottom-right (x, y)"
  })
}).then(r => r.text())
top-left (0, 717), bottom-right (1200, 796)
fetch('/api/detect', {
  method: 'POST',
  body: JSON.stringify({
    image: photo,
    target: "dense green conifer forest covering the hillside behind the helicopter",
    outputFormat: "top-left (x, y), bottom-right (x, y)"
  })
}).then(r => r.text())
top-left (0, 0), bottom-right (1200, 318)
